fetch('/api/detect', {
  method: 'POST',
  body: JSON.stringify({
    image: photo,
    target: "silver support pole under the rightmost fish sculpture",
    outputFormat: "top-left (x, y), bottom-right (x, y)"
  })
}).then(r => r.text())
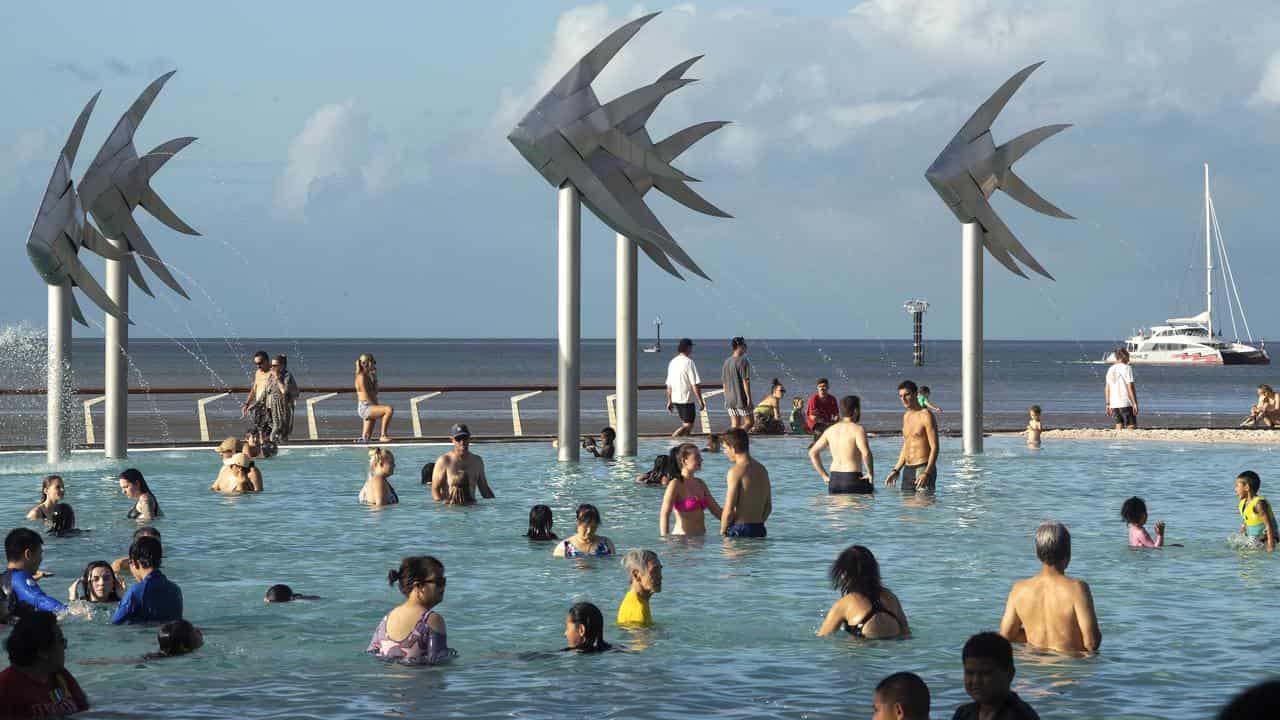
top-left (960, 223), bottom-right (983, 455)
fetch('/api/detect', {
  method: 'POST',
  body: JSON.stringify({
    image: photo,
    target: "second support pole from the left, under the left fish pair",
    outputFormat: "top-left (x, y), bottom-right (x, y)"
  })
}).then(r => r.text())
top-left (102, 240), bottom-right (129, 459)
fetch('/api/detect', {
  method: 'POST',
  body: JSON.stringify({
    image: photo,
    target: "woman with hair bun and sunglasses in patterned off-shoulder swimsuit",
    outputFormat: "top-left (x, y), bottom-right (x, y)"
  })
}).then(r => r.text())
top-left (365, 555), bottom-right (457, 665)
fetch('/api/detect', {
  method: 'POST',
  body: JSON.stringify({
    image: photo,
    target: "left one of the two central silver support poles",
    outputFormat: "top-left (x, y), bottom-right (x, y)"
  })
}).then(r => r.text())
top-left (556, 183), bottom-right (582, 462)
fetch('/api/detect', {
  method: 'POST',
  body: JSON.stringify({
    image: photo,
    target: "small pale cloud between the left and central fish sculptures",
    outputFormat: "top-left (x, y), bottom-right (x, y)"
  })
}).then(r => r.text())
top-left (275, 100), bottom-right (401, 215)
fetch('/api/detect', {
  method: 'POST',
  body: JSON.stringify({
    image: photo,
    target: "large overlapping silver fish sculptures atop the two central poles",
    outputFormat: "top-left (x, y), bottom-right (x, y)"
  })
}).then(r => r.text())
top-left (507, 13), bottom-right (707, 278)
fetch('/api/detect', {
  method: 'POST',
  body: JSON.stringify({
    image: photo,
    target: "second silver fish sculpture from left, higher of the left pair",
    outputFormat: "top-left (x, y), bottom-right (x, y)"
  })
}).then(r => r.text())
top-left (79, 70), bottom-right (200, 299)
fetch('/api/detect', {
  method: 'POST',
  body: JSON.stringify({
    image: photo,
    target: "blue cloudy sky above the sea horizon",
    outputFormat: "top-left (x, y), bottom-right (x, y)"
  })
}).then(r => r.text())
top-left (0, 0), bottom-right (1280, 340)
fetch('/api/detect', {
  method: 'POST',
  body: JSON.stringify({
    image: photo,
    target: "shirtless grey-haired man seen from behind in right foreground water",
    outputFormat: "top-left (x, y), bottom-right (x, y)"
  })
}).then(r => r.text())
top-left (1000, 523), bottom-right (1102, 652)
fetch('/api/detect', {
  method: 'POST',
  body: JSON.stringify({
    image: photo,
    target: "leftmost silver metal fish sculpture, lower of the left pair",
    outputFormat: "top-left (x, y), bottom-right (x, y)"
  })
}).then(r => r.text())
top-left (27, 94), bottom-right (125, 325)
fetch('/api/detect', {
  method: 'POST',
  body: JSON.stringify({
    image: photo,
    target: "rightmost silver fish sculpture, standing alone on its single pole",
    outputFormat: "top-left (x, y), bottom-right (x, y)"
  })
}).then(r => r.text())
top-left (924, 61), bottom-right (1075, 279)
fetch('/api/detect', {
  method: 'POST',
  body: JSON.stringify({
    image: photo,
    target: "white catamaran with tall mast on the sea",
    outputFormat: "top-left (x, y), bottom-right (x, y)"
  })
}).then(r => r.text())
top-left (1103, 163), bottom-right (1271, 365)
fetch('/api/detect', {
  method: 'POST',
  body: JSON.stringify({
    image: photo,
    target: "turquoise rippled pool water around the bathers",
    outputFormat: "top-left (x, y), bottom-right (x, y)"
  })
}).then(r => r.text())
top-left (0, 438), bottom-right (1280, 719)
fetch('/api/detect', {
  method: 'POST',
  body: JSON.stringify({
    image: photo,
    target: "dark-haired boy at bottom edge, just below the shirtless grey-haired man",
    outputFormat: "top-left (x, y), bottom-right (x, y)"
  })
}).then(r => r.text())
top-left (951, 633), bottom-right (1039, 720)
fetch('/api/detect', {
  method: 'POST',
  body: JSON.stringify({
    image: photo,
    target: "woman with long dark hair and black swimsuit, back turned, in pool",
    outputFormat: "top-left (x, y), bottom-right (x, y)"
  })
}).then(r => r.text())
top-left (818, 544), bottom-right (911, 639)
